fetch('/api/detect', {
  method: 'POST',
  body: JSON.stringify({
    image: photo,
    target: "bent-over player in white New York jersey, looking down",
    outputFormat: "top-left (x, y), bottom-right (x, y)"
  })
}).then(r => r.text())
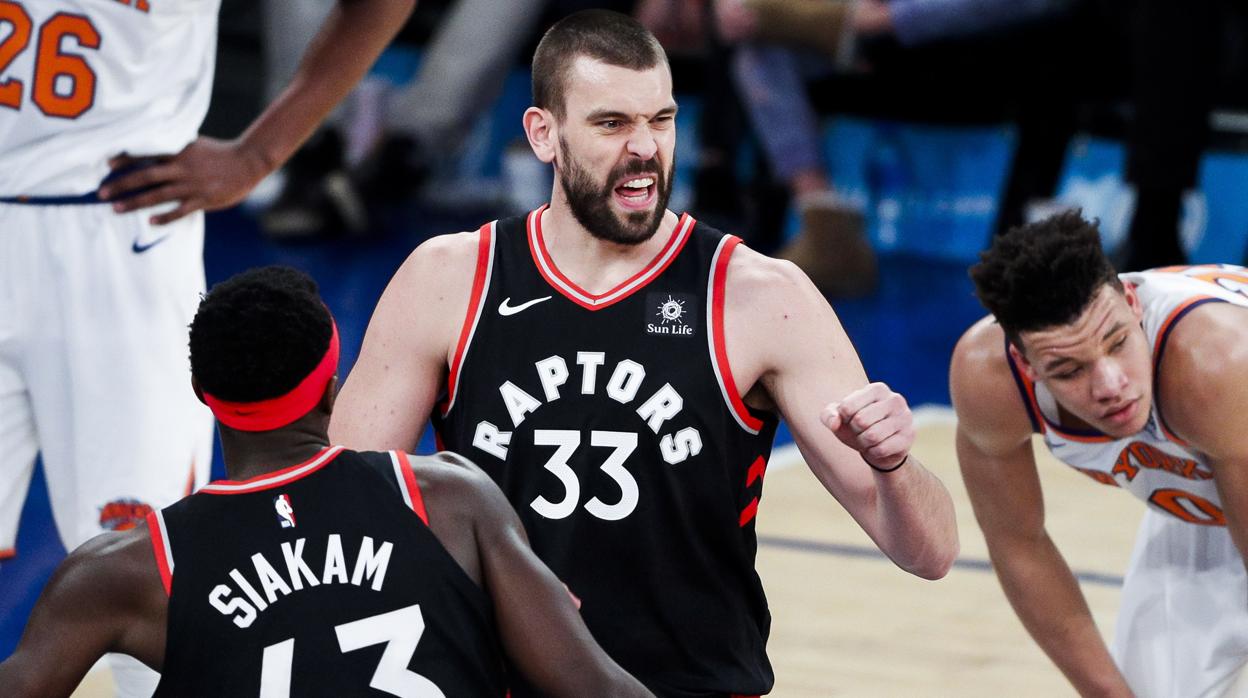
top-left (951, 212), bottom-right (1248, 697)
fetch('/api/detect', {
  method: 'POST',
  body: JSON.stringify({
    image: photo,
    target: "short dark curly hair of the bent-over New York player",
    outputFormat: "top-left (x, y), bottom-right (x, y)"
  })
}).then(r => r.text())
top-left (971, 210), bottom-right (1122, 348)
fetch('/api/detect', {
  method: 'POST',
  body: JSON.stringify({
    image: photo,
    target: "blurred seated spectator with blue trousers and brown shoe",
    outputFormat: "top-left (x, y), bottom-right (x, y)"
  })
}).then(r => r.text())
top-left (715, 0), bottom-right (1088, 295)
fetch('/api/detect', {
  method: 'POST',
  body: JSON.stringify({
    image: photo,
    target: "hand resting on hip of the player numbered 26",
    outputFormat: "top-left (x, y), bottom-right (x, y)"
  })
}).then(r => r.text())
top-left (100, 136), bottom-right (270, 225)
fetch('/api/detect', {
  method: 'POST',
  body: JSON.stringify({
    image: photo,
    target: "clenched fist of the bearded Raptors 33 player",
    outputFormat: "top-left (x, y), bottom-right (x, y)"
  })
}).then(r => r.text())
top-left (819, 383), bottom-right (915, 469)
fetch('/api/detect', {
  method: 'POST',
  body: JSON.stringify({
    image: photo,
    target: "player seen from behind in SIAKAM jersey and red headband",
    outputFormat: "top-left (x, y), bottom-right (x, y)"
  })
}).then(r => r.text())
top-left (0, 267), bottom-right (649, 697)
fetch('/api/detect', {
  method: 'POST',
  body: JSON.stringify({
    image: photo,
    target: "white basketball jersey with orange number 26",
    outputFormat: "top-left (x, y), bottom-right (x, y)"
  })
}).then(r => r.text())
top-left (0, 0), bottom-right (220, 196)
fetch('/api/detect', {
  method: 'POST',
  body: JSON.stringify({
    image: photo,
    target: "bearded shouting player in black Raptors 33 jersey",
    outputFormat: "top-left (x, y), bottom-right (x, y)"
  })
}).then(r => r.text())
top-left (332, 10), bottom-right (957, 696)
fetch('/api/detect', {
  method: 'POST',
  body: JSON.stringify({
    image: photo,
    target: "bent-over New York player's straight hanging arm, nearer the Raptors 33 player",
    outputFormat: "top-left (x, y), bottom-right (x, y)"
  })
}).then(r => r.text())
top-left (950, 321), bottom-right (1131, 696)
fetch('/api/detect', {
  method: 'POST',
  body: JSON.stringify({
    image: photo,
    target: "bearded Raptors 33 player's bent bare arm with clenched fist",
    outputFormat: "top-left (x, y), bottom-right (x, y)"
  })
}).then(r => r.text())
top-left (724, 247), bottom-right (958, 579)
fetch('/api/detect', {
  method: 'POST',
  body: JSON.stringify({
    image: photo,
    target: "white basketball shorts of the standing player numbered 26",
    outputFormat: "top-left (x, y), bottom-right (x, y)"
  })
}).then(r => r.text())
top-left (0, 202), bottom-right (212, 557)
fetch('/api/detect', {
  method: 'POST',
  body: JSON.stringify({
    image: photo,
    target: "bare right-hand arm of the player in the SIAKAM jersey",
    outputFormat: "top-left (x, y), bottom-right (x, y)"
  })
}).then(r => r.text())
top-left (416, 453), bottom-right (651, 698)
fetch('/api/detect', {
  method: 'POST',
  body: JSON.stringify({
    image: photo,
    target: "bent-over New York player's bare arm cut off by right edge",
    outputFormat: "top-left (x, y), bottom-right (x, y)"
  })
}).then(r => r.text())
top-left (1158, 303), bottom-right (1248, 563)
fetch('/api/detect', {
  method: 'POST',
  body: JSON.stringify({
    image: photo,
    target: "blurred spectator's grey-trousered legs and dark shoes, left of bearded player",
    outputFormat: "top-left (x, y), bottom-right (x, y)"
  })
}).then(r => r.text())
top-left (261, 0), bottom-right (634, 237)
